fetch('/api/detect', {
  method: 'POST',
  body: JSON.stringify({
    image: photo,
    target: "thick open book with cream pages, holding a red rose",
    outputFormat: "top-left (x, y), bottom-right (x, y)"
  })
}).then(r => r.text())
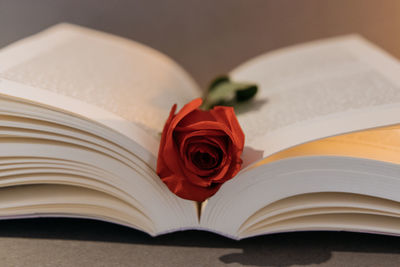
top-left (0, 24), bottom-right (400, 239)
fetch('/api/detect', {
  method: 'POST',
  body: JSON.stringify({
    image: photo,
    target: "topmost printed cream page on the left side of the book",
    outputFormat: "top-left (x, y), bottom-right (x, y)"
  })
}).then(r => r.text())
top-left (0, 24), bottom-right (200, 150)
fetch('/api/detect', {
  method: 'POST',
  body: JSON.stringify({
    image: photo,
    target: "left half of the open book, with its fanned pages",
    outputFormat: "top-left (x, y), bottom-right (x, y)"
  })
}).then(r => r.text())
top-left (0, 24), bottom-right (200, 235)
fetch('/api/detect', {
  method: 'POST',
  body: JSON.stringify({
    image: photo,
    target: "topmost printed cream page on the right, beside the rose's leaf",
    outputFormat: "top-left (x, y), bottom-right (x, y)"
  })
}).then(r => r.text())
top-left (232, 36), bottom-right (400, 159)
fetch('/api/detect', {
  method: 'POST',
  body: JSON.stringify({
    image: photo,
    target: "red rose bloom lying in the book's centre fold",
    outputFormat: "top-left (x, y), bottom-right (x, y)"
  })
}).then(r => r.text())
top-left (157, 98), bottom-right (244, 201)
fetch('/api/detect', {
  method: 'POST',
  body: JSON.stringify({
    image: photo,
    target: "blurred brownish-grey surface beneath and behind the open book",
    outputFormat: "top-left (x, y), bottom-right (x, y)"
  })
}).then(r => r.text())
top-left (0, 0), bottom-right (400, 266)
